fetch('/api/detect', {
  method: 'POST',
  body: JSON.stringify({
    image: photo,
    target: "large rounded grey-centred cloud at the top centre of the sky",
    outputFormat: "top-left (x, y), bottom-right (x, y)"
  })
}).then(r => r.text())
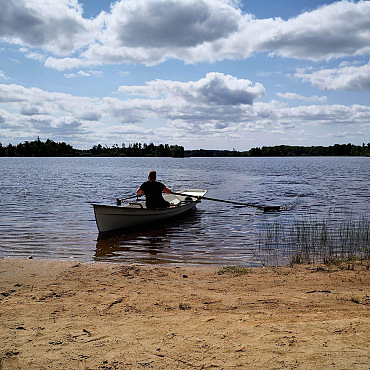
top-left (107, 0), bottom-right (241, 49)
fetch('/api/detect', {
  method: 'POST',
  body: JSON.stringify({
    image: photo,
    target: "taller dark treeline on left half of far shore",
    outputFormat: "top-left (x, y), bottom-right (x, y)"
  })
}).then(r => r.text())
top-left (0, 138), bottom-right (184, 157)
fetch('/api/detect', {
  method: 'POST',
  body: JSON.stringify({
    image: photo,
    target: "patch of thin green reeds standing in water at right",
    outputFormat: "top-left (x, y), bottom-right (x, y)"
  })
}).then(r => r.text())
top-left (258, 215), bottom-right (370, 265)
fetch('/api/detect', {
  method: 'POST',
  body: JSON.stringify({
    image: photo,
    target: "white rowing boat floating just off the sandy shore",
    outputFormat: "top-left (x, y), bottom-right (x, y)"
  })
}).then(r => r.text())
top-left (93, 189), bottom-right (207, 232)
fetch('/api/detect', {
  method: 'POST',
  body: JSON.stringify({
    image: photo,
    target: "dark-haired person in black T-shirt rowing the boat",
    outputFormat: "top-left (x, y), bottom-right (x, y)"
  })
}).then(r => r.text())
top-left (136, 170), bottom-right (171, 208)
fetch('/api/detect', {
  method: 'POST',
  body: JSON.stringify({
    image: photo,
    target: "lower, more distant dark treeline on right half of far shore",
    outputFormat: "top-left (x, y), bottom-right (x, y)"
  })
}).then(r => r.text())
top-left (185, 143), bottom-right (370, 157)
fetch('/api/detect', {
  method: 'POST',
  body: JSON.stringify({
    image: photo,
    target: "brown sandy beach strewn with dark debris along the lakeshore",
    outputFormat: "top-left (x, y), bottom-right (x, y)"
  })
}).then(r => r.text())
top-left (0, 258), bottom-right (370, 369)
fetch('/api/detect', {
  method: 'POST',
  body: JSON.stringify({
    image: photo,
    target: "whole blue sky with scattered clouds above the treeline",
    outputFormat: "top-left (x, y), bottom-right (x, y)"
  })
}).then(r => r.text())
top-left (0, 0), bottom-right (370, 150)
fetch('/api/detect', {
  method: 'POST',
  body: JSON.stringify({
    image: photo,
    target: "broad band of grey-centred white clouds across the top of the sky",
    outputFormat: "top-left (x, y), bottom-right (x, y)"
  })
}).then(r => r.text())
top-left (0, 0), bottom-right (370, 71)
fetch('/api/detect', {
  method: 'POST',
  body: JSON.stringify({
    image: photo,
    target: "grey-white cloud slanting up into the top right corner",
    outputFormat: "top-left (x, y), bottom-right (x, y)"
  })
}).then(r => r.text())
top-left (259, 1), bottom-right (370, 61)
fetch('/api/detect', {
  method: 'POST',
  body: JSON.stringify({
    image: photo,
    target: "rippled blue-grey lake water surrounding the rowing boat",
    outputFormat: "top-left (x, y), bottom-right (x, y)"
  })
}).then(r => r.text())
top-left (0, 157), bottom-right (370, 266)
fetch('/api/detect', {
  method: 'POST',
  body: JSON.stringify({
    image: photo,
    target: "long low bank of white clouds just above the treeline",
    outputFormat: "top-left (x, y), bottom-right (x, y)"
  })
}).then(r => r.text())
top-left (0, 73), bottom-right (370, 145)
